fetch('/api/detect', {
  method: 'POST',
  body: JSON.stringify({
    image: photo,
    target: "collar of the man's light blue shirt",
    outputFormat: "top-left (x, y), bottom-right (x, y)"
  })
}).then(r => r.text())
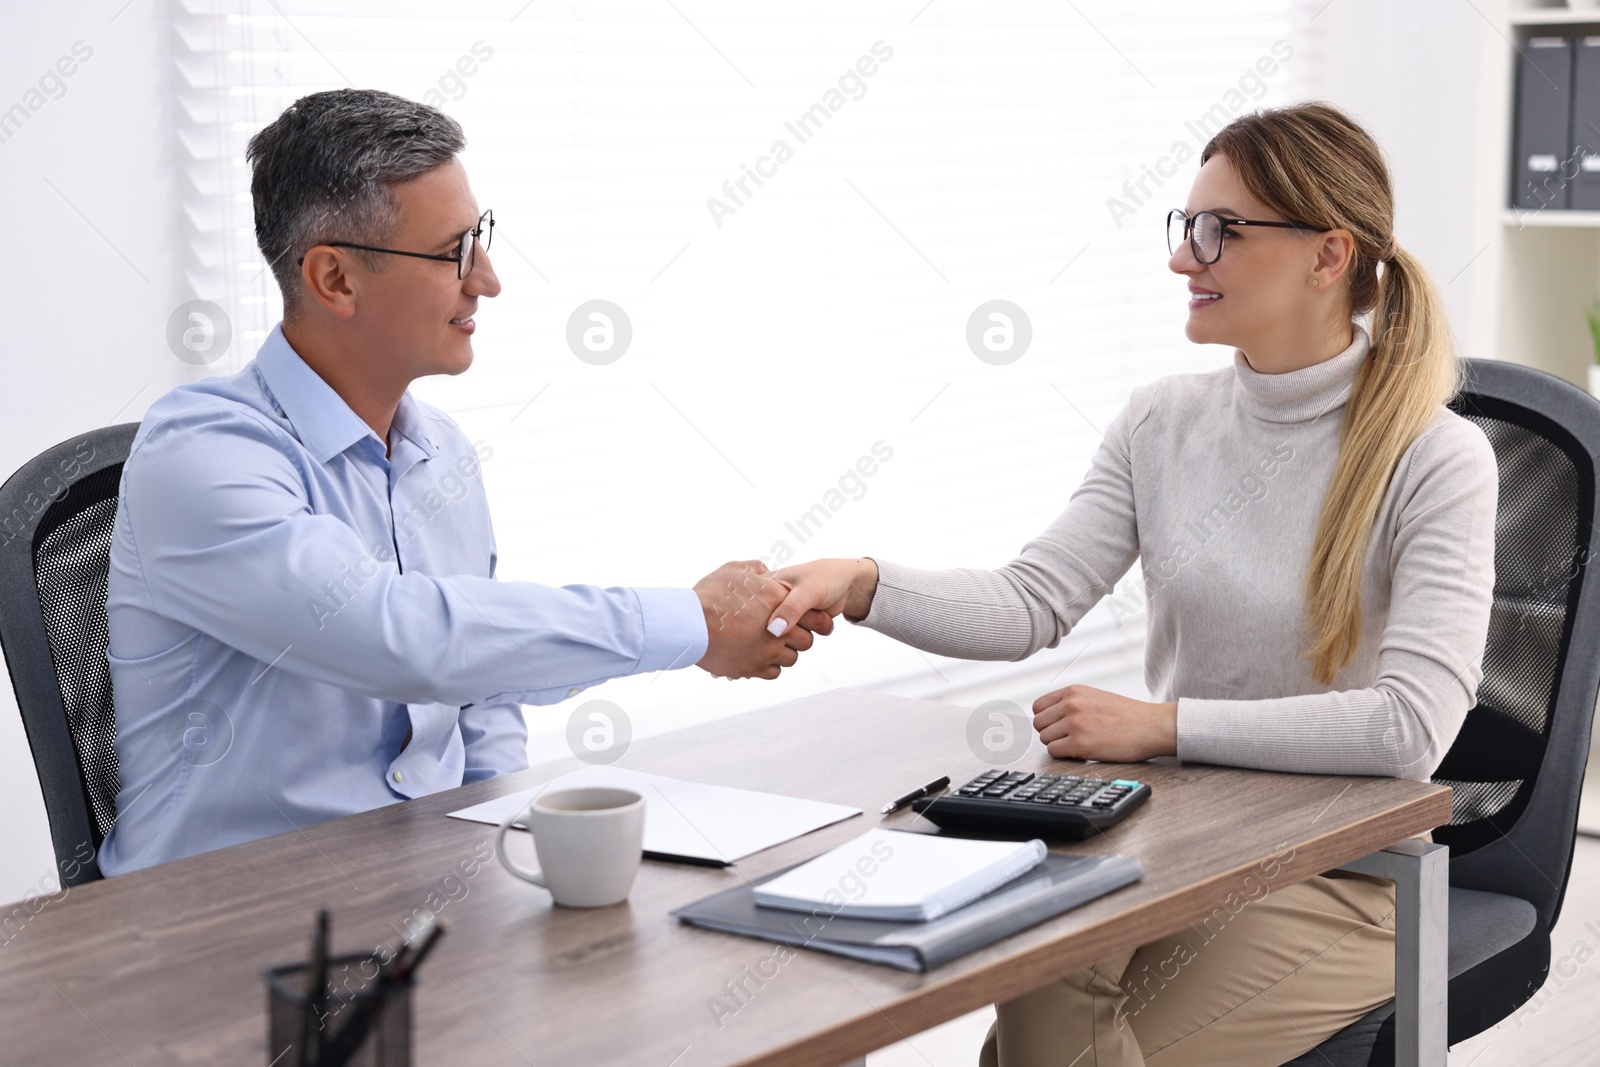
top-left (256, 323), bottom-right (438, 464)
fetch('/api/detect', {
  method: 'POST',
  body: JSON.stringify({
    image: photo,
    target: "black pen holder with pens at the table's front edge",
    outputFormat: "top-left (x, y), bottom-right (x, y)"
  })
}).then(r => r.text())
top-left (262, 953), bottom-right (411, 1067)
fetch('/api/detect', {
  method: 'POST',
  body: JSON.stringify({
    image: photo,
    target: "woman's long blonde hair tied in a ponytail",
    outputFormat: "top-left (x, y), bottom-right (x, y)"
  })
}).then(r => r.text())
top-left (1200, 104), bottom-right (1459, 685)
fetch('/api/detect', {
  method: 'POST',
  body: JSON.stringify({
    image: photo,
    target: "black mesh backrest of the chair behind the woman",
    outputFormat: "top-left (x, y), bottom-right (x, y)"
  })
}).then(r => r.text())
top-left (1434, 360), bottom-right (1600, 925)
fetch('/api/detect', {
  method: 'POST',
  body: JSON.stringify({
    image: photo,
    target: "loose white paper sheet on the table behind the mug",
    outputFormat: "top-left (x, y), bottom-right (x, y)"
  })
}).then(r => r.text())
top-left (450, 766), bottom-right (861, 864)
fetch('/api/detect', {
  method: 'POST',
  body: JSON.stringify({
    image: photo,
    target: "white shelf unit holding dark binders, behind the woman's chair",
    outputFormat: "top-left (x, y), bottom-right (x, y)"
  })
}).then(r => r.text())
top-left (1490, 0), bottom-right (1600, 389)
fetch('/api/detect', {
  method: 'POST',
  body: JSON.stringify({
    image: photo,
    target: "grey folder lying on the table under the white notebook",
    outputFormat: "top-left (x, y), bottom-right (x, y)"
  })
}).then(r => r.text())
top-left (672, 853), bottom-right (1144, 971)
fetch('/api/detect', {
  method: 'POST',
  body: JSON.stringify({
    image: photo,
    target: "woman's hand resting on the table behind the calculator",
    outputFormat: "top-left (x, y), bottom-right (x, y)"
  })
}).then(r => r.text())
top-left (1034, 685), bottom-right (1178, 763)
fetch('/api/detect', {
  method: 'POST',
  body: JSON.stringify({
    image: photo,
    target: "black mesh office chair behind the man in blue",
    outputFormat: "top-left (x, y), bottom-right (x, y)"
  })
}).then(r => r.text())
top-left (0, 422), bottom-right (139, 888)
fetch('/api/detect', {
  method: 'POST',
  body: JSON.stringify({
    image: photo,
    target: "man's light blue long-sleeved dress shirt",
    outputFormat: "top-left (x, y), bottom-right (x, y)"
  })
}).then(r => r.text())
top-left (99, 326), bottom-right (707, 875)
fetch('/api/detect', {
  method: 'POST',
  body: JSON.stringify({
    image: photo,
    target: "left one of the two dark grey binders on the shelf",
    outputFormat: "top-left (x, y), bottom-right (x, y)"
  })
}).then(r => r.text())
top-left (1512, 37), bottom-right (1578, 208)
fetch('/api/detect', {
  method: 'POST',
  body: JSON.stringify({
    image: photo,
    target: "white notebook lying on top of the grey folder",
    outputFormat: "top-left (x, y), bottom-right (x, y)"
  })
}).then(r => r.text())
top-left (755, 829), bottom-right (1046, 923)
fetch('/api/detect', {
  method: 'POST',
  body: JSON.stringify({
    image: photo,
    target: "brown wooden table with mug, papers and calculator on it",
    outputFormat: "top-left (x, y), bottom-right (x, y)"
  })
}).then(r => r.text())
top-left (0, 686), bottom-right (1450, 1067)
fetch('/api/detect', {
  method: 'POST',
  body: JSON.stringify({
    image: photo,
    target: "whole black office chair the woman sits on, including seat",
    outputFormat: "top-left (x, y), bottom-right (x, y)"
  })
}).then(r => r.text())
top-left (1285, 360), bottom-right (1600, 1067)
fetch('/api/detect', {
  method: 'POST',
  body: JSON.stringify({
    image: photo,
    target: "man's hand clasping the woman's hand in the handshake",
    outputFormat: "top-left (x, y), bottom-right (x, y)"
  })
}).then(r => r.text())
top-left (694, 560), bottom-right (834, 678)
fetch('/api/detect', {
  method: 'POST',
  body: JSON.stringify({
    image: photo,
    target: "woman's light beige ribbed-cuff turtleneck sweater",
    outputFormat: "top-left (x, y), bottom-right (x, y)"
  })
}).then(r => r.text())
top-left (861, 325), bottom-right (1498, 779)
